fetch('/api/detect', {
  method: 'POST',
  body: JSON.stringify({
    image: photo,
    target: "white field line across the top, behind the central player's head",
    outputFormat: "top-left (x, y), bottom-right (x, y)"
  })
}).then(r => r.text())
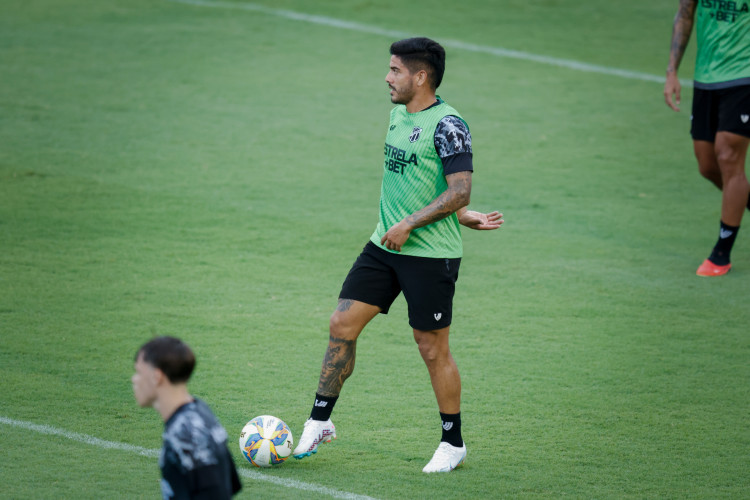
top-left (168, 0), bottom-right (693, 87)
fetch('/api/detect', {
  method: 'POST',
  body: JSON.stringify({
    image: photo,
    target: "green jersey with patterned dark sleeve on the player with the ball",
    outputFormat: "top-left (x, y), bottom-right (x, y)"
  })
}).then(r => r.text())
top-left (370, 98), bottom-right (473, 259)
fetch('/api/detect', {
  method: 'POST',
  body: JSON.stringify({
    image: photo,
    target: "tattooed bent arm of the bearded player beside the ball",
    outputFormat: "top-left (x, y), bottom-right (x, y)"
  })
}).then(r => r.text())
top-left (380, 171), bottom-right (471, 252)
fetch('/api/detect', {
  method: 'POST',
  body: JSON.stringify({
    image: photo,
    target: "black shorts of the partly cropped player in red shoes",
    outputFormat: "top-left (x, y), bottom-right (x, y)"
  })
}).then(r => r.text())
top-left (690, 85), bottom-right (750, 142)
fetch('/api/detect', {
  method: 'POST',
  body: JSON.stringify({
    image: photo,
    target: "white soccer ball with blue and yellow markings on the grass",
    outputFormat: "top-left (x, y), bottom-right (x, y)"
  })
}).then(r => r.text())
top-left (240, 415), bottom-right (294, 467)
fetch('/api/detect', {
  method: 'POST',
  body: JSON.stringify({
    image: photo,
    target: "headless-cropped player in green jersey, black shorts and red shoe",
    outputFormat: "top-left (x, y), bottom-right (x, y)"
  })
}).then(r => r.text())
top-left (664, 0), bottom-right (750, 276)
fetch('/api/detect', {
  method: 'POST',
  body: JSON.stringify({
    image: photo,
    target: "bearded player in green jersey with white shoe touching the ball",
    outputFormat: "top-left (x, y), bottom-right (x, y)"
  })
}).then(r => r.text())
top-left (294, 38), bottom-right (503, 472)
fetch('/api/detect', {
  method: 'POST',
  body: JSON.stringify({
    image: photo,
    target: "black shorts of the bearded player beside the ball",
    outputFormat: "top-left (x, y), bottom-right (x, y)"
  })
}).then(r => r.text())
top-left (339, 241), bottom-right (461, 331)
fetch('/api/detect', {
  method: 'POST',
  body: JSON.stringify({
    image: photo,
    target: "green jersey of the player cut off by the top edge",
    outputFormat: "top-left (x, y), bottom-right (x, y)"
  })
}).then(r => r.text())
top-left (695, 0), bottom-right (750, 89)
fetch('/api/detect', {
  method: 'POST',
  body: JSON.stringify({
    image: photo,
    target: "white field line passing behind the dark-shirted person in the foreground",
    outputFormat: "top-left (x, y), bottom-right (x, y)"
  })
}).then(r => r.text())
top-left (0, 416), bottom-right (382, 500)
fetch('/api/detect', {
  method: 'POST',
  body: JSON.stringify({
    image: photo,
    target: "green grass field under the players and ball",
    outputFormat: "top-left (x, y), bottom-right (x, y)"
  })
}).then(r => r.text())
top-left (0, 0), bottom-right (750, 499)
